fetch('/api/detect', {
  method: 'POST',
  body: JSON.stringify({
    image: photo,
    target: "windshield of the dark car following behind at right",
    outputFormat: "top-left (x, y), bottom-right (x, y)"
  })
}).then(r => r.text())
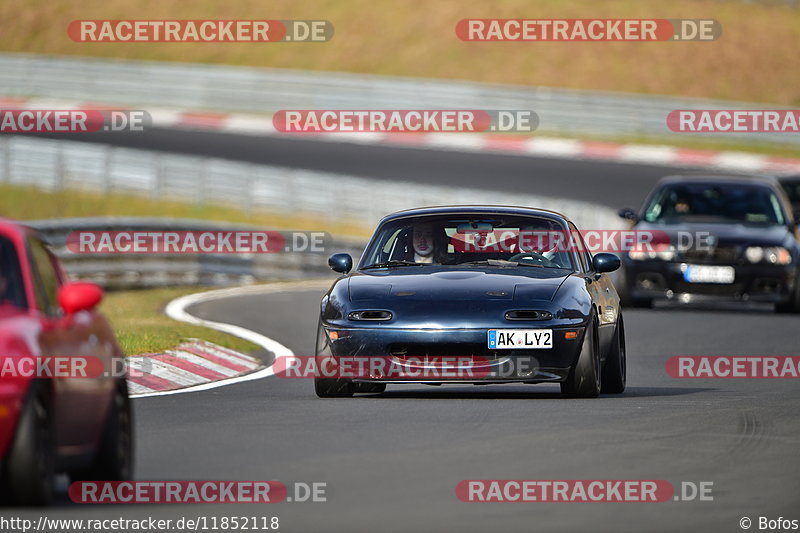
top-left (644, 183), bottom-right (785, 225)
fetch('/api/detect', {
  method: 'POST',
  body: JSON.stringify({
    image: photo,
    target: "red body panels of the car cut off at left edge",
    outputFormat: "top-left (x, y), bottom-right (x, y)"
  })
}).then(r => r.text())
top-left (0, 219), bottom-right (123, 470)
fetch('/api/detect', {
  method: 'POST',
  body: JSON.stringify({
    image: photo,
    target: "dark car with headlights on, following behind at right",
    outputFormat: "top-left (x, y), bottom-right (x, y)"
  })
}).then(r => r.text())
top-left (619, 176), bottom-right (800, 312)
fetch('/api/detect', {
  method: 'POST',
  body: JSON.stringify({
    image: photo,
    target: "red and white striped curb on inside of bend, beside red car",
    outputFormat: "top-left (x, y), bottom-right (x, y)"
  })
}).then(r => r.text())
top-left (127, 339), bottom-right (262, 397)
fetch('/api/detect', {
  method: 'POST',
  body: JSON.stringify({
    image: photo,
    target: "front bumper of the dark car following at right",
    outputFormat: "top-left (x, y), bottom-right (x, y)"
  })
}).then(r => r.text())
top-left (625, 259), bottom-right (798, 303)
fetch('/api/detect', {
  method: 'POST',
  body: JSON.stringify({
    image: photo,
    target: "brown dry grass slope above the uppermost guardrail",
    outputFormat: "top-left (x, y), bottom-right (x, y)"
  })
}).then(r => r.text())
top-left (0, 0), bottom-right (800, 106)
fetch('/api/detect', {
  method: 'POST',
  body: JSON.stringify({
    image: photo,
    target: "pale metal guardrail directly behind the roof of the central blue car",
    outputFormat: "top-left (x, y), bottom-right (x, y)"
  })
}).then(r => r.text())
top-left (0, 136), bottom-right (618, 231)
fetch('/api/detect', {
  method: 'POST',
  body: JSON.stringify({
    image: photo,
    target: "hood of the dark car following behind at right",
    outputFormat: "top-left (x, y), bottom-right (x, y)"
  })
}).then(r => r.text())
top-left (635, 222), bottom-right (789, 246)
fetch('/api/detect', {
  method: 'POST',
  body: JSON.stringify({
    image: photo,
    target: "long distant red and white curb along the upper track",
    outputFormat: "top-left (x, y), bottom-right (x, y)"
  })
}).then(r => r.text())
top-left (0, 93), bottom-right (800, 174)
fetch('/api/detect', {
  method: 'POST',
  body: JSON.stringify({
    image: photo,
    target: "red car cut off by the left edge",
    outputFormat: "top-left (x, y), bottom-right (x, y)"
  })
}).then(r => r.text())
top-left (0, 219), bottom-right (133, 505)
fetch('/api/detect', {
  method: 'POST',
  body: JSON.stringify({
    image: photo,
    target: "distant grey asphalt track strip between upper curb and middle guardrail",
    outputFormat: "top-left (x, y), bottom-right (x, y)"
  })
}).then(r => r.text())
top-left (23, 128), bottom-right (685, 208)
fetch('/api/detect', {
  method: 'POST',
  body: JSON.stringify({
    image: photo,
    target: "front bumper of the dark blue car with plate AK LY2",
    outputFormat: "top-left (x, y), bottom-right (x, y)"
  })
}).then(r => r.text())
top-left (317, 325), bottom-right (585, 384)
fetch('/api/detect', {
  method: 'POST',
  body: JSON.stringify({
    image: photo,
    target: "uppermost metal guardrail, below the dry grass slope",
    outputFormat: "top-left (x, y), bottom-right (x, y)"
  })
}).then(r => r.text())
top-left (0, 54), bottom-right (800, 144)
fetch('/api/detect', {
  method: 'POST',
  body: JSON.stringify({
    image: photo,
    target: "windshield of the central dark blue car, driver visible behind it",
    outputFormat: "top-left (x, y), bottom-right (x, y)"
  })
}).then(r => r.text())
top-left (360, 214), bottom-right (573, 270)
